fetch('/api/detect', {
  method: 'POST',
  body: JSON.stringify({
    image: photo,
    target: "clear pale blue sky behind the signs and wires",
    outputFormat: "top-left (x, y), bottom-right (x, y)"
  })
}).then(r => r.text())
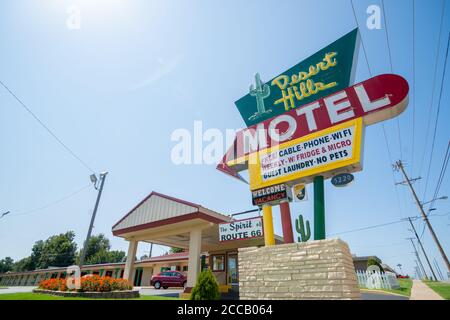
top-left (0, 0), bottom-right (450, 274)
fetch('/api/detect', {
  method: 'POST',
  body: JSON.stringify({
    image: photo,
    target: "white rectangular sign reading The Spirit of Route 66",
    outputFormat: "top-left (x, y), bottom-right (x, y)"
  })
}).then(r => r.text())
top-left (219, 217), bottom-right (264, 242)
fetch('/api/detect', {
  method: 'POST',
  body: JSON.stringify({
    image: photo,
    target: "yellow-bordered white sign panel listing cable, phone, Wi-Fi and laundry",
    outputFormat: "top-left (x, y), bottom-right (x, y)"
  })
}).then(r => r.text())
top-left (249, 118), bottom-right (363, 190)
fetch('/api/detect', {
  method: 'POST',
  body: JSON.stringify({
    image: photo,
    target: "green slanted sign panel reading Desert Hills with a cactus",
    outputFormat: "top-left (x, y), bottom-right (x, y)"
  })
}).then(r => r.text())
top-left (235, 29), bottom-right (359, 127)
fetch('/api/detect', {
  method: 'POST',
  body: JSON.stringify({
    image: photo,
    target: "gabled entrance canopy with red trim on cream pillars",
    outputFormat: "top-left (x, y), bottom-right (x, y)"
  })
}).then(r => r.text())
top-left (112, 192), bottom-right (234, 288)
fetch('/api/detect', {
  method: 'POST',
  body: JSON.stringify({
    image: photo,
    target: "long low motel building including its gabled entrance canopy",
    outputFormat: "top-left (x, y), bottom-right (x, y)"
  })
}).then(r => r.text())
top-left (0, 192), bottom-right (283, 293)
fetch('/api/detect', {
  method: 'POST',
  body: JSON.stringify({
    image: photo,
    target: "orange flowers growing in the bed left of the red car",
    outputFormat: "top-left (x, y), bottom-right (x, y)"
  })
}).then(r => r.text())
top-left (39, 275), bottom-right (133, 292)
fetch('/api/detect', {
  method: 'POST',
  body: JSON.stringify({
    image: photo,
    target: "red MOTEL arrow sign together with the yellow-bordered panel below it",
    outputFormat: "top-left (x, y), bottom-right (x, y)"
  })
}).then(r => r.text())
top-left (217, 74), bottom-right (409, 190)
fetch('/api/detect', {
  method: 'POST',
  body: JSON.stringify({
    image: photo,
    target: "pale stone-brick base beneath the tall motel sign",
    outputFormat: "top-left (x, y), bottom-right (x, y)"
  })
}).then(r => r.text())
top-left (238, 239), bottom-right (361, 300)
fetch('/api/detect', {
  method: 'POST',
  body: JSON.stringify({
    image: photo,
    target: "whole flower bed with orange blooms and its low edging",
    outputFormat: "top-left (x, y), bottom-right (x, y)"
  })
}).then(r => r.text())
top-left (33, 275), bottom-right (139, 298)
